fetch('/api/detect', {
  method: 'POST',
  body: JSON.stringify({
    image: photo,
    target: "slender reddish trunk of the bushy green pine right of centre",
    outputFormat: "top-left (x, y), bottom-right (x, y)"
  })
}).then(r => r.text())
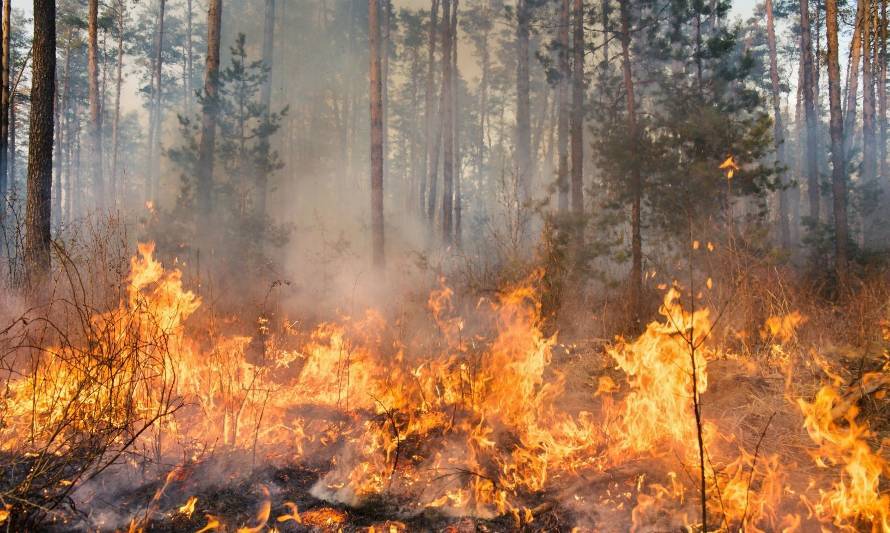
top-left (619, 0), bottom-right (643, 330)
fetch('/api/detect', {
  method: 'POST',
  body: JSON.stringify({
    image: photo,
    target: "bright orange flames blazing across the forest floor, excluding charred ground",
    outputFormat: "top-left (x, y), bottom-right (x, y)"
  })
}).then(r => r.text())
top-left (0, 245), bottom-right (890, 532)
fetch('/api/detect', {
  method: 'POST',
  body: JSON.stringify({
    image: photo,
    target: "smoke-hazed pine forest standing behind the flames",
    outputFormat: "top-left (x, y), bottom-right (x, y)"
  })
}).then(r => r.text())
top-left (0, 0), bottom-right (888, 316)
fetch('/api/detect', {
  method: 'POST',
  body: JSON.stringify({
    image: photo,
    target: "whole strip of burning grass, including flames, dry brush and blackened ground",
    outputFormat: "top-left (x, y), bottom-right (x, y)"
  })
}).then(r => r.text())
top-left (0, 245), bottom-right (890, 532)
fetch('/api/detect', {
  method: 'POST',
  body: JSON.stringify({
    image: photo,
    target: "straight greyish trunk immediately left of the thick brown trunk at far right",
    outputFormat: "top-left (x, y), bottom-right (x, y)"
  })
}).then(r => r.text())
top-left (800, 0), bottom-right (820, 224)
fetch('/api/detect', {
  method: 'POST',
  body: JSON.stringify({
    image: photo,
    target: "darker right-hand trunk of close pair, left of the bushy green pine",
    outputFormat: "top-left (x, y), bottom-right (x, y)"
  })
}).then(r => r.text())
top-left (571, 0), bottom-right (584, 215)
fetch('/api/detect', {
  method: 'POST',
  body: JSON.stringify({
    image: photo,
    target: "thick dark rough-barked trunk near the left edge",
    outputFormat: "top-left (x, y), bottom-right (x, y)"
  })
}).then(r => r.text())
top-left (25, 0), bottom-right (56, 284)
